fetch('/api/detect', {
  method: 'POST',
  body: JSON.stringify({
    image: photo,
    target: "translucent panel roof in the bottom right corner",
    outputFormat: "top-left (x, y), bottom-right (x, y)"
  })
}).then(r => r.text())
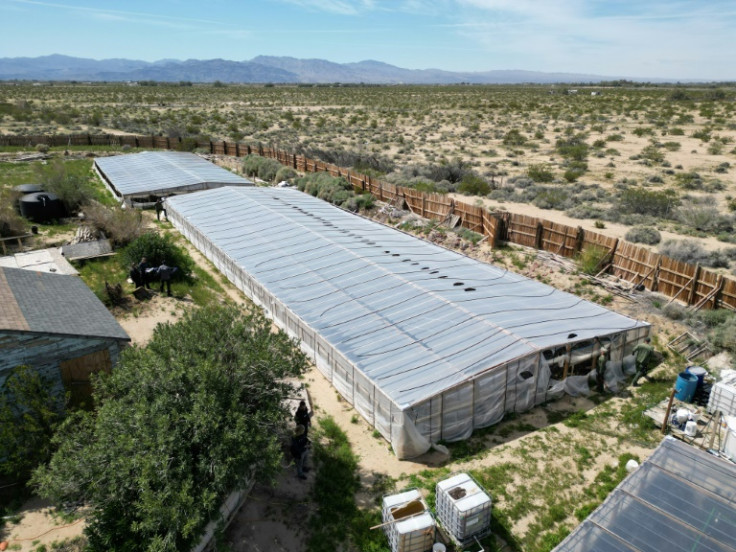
top-left (554, 437), bottom-right (736, 552)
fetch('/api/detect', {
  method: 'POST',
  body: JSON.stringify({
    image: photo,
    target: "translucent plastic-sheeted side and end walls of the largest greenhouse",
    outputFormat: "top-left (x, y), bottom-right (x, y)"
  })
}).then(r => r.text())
top-left (168, 207), bottom-right (649, 459)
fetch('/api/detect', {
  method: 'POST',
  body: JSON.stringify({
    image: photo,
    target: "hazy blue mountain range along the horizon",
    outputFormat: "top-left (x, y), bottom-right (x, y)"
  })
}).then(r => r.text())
top-left (0, 54), bottom-right (660, 84)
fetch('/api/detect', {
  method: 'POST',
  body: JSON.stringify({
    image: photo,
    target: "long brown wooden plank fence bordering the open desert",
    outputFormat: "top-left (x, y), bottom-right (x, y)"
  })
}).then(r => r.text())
top-left (0, 134), bottom-right (736, 309)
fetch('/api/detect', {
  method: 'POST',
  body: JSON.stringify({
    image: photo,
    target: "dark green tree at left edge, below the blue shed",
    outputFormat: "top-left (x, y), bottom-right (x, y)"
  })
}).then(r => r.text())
top-left (0, 366), bottom-right (65, 480)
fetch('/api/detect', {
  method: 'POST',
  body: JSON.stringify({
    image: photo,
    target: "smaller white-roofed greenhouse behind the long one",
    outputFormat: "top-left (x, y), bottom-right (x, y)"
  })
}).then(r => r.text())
top-left (95, 151), bottom-right (253, 207)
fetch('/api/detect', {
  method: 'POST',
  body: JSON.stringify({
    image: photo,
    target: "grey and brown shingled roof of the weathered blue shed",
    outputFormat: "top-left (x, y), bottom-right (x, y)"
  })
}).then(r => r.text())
top-left (0, 267), bottom-right (130, 341)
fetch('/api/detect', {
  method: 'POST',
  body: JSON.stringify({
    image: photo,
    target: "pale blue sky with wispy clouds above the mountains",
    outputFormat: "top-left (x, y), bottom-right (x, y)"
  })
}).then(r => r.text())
top-left (0, 0), bottom-right (736, 81)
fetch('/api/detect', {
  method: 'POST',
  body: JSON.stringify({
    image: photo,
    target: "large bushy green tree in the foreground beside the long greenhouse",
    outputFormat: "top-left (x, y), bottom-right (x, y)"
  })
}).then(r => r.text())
top-left (33, 306), bottom-right (306, 552)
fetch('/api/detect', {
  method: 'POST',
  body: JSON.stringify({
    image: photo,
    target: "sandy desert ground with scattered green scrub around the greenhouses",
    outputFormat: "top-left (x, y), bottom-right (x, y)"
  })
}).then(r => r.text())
top-left (0, 82), bottom-right (736, 552)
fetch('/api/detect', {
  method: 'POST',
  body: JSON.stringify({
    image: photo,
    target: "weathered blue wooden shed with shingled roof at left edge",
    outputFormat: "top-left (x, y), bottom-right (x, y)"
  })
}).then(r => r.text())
top-left (0, 267), bottom-right (130, 404)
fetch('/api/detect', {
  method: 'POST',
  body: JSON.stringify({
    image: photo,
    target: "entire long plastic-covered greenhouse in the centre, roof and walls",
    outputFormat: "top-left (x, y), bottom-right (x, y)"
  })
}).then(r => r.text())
top-left (169, 187), bottom-right (649, 458)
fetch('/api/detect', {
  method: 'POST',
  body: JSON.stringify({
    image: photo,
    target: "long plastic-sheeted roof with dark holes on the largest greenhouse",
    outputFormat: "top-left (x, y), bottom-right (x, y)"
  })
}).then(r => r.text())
top-left (169, 188), bottom-right (647, 409)
